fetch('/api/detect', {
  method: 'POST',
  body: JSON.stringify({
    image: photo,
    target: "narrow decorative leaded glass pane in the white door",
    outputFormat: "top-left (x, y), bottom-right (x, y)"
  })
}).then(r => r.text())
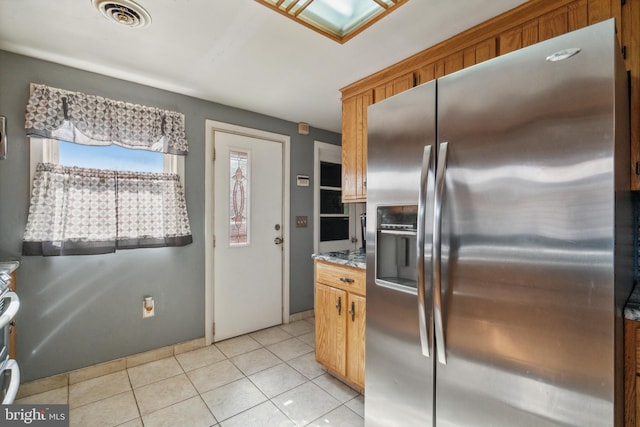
top-left (229, 150), bottom-right (250, 247)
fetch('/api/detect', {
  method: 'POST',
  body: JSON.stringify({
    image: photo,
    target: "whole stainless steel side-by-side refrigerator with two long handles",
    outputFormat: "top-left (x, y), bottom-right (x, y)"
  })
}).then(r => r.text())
top-left (365, 21), bottom-right (633, 427)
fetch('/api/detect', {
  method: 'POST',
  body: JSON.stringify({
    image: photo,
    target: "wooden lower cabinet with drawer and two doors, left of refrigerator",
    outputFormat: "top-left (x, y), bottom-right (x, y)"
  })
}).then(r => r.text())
top-left (315, 260), bottom-right (366, 390)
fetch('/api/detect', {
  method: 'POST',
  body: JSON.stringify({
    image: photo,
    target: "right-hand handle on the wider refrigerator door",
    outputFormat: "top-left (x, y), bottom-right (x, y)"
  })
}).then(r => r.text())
top-left (431, 142), bottom-right (449, 365)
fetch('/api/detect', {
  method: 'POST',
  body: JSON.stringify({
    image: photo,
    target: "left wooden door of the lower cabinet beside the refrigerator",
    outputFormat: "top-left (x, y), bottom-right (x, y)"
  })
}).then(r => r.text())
top-left (315, 283), bottom-right (348, 376)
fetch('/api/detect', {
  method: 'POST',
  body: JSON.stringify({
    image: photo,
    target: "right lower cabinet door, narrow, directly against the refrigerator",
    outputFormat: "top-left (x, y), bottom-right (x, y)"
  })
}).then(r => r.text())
top-left (347, 294), bottom-right (366, 389)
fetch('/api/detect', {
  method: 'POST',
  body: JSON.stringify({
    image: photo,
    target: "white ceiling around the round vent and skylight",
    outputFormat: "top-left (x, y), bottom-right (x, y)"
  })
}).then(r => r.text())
top-left (0, 0), bottom-right (525, 132)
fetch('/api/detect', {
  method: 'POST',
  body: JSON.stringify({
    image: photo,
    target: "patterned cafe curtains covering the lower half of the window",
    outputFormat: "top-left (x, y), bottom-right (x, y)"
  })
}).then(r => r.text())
top-left (22, 163), bottom-right (192, 256)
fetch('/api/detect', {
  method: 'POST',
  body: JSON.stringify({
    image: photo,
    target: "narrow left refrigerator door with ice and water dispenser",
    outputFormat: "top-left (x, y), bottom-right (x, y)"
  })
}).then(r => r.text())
top-left (365, 82), bottom-right (436, 427)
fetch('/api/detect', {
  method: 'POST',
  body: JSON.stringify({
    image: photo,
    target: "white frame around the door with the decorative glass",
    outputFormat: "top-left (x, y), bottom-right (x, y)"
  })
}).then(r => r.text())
top-left (204, 120), bottom-right (291, 345)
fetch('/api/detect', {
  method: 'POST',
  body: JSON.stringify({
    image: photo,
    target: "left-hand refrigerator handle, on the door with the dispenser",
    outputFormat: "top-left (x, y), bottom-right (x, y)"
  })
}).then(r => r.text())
top-left (416, 145), bottom-right (432, 357)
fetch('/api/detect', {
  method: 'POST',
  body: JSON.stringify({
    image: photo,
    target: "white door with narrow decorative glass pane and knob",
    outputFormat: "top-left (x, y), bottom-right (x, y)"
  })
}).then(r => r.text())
top-left (213, 132), bottom-right (283, 341)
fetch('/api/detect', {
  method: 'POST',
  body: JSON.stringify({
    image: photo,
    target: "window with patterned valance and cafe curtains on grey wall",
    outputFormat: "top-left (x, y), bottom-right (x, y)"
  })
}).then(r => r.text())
top-left (23, 85), bottom-right (192, 255)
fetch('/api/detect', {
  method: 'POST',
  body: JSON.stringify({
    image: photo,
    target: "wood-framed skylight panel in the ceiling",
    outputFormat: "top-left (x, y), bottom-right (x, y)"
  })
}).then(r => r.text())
top-left (256, 0), bottom-right (409, 43)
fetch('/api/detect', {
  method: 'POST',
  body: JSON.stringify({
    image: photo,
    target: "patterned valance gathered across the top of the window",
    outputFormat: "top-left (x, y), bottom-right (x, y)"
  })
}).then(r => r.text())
top-left (25, 84), bottom-right (189, 155)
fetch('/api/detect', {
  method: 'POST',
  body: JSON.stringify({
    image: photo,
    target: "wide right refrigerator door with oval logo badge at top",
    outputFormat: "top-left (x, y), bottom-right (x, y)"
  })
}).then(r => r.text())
top-left (436, 21), bottom-right (633, 427)
